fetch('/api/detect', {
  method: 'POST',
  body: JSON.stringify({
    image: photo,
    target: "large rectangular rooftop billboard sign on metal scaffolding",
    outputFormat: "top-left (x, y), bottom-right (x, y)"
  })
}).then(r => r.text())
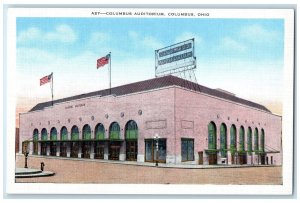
top-left (155, 39), bottom-right (196, 77)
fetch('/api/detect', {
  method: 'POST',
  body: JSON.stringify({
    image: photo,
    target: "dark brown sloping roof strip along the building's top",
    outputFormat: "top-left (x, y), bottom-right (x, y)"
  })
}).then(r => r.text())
top-left (29, 75), bottom-right (271, 113)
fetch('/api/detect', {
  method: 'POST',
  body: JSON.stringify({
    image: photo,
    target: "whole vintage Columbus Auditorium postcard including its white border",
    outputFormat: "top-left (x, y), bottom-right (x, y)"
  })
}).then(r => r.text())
top-left (6, 8), bottom-right (294, 195)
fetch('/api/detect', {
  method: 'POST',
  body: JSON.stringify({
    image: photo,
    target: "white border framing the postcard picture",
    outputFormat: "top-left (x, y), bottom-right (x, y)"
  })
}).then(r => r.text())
top-left (6, 8), bottom-right (294, 195)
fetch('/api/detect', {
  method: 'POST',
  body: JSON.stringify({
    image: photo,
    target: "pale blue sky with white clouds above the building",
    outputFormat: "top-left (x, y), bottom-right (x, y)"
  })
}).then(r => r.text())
top-left (17, 18), bottom-right (284, 109)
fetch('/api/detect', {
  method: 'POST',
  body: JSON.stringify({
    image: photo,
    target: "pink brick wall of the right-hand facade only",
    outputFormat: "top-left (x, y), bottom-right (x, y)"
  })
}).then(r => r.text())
top-left (175, 88), bottom-right (282, 164)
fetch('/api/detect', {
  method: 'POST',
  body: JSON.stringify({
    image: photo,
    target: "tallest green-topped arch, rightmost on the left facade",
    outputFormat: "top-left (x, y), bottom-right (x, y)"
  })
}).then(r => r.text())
top-left (125, 120), bottom-right (138, 161)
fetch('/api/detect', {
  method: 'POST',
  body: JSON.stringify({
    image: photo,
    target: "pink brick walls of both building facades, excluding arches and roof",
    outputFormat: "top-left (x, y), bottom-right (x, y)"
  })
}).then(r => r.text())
top-left (20, 87), bottom-right (281, 164)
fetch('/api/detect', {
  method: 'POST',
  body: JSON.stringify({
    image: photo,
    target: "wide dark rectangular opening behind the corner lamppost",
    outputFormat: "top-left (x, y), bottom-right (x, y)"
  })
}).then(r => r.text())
top-left (145, 139), bottom-right (167, 163)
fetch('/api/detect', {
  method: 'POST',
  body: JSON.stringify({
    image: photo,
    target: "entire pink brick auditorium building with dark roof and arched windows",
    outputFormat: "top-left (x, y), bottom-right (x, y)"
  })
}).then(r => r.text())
top-left (20, 75), bottom-right (282, 165)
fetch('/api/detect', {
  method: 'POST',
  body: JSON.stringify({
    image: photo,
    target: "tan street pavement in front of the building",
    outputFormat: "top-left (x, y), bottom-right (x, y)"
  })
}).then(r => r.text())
top-left (15, 155), bottom-right (282, 185)
